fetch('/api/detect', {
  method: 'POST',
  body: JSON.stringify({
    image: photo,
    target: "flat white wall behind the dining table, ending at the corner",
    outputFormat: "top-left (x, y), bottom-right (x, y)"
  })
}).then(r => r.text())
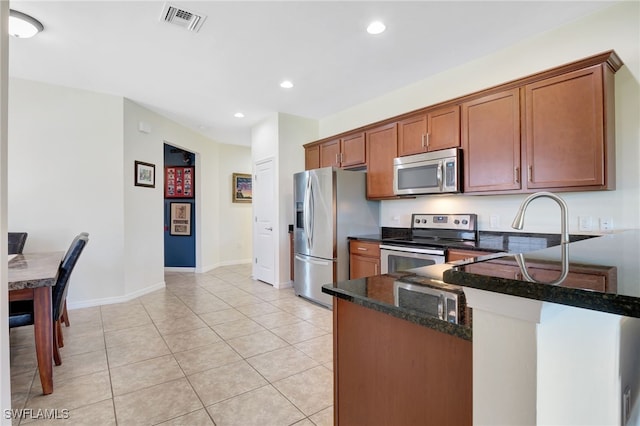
top-left (8, 79), bottom-right (126, 305)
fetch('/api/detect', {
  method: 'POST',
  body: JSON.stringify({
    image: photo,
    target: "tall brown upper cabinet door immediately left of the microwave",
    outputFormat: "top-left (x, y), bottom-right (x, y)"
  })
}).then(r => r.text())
top-left (366, 123), bottom-right (398, 198)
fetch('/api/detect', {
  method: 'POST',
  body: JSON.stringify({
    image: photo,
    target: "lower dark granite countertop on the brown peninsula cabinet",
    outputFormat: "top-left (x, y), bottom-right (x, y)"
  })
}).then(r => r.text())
top-left (322, 273), bottom-right (472, 340)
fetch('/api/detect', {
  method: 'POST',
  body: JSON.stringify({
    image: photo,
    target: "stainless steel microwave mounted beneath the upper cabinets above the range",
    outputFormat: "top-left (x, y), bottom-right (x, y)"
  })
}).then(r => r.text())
top-left (393, 148), bottom-right (462, 195)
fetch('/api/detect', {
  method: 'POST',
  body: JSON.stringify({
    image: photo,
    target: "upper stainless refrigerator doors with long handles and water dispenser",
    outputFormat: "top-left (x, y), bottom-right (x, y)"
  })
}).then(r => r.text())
top-left (294, 167), bottom-right (336, 259)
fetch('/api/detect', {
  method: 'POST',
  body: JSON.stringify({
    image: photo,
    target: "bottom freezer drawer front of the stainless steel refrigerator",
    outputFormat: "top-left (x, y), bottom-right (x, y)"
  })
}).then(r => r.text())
top-left (293, 254), bottom-right (336, 308)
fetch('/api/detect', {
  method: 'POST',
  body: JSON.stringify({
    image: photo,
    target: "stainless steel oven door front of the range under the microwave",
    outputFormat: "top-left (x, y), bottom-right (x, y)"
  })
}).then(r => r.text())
top-left (380, 244), bottom-right (445, 274)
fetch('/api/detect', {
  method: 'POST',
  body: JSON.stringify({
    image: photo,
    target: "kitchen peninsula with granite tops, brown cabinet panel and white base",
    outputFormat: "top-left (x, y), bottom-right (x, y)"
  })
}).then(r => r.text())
top-left (323, 231), bottom-right (640, 425)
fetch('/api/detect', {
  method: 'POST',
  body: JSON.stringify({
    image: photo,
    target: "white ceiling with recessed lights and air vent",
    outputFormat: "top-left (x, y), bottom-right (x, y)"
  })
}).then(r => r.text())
top-left (9, 0), bottom-right (614, 145)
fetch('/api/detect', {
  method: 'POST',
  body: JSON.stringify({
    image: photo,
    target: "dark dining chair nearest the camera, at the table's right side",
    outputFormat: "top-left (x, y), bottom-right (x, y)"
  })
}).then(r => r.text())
top-left (9, 233), bottom-right (89, 365)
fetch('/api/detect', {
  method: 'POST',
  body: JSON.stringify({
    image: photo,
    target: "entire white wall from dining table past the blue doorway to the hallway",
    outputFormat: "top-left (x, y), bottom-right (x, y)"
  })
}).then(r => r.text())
top-left (7, 79), bottom-right (252, 308)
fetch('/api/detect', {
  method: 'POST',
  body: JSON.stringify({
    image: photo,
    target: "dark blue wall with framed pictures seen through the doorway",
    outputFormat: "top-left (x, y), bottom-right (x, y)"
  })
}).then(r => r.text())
top-left (161, 144), bottom-right (199, 268)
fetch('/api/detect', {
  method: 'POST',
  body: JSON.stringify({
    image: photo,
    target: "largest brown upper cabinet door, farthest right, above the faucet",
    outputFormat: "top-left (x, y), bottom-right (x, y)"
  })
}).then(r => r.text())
top-left (525, 65), bottom-right (605, 188)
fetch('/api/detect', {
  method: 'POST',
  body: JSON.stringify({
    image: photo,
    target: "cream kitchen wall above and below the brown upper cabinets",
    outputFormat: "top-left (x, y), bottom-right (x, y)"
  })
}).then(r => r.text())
top-left (319, 2), bottom-right (640, 233)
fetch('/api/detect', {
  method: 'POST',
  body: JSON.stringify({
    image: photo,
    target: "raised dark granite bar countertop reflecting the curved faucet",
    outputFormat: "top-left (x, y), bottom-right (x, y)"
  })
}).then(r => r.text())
top-left (443, 230), bottom-right (640, 318)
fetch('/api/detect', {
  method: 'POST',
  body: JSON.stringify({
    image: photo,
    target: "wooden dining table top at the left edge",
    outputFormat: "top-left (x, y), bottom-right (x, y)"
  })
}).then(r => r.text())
top-left (8, 251), bottom-right (64, 291)
